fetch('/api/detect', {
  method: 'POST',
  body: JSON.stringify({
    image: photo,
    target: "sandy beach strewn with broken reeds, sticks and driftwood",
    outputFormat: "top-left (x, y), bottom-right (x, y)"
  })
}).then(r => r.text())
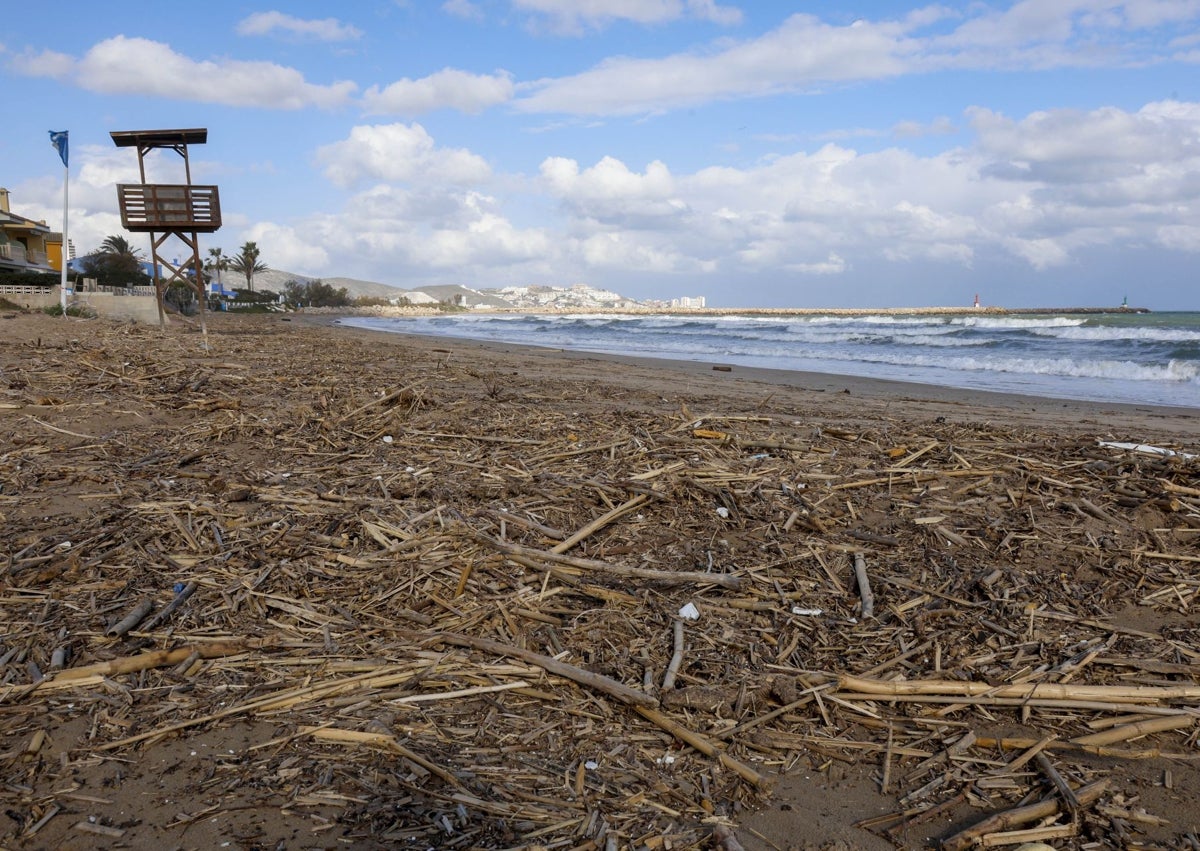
top-left (0, 313), bottom-right (1200, 851)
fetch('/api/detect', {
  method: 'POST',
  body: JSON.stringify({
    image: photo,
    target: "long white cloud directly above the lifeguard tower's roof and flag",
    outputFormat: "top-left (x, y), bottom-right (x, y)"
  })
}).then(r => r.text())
top-left (16, 36), bottom-right (358, 109)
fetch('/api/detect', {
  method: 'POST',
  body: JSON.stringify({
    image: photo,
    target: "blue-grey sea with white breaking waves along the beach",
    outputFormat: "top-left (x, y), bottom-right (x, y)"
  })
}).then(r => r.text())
top-left (341, 312), bottom-right (1200, 408)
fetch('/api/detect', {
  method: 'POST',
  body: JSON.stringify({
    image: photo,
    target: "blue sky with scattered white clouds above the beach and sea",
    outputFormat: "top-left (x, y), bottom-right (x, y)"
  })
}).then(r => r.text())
top-left (0, 0), bottom-right (1200, 310)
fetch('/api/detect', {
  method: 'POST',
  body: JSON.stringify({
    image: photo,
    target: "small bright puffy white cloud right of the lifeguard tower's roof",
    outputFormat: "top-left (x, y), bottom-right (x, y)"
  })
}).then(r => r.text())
top-left (317, 124), bottom-right (491, 186)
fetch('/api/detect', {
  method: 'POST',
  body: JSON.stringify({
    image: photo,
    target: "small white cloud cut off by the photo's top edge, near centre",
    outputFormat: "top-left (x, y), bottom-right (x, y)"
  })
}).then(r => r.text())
top-left (512, 0), bottom-right (742, 34)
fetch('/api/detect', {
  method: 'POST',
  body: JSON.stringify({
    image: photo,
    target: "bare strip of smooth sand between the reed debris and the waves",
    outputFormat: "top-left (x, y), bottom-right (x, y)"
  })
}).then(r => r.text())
top-left (306, 316), bottom-right (1200, 438)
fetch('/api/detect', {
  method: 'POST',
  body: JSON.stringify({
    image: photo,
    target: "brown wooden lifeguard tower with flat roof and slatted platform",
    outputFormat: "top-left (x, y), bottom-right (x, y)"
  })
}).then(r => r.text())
top-left (109, 127), bottom-right (221, 328)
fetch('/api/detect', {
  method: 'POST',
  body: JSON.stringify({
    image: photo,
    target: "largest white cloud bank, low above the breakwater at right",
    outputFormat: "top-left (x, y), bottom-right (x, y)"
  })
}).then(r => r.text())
top-left (528, 94), bottom-right (1200, 276)
